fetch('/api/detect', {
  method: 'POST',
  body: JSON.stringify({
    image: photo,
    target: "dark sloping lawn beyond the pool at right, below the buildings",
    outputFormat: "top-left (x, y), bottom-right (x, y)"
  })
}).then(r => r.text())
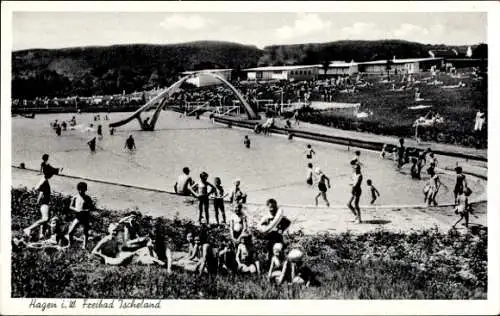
top-left (294, 74), bottom-right (488, 146)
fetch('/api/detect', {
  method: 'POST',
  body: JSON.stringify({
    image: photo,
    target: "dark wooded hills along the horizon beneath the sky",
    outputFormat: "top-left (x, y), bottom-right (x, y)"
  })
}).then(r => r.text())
top-left (12, 40), bottom-right (487, 99)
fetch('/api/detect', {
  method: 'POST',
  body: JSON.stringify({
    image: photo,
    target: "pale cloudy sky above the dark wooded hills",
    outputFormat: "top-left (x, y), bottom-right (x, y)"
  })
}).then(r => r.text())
top-left (12, 12), bottom-right (487, 51)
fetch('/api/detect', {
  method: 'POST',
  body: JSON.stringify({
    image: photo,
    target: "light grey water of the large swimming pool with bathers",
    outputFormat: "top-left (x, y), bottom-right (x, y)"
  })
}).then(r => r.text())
top-left (12, 111), bottom-right (484, 205)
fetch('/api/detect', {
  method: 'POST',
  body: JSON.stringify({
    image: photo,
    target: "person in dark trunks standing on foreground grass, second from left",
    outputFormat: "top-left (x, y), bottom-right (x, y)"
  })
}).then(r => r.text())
top-left (66, 182), bottom-right (94, 249)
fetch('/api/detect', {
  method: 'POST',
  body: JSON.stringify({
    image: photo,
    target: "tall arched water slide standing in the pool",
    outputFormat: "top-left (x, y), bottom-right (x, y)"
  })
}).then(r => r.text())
top-left (109, 71), bottom-right (258, 131)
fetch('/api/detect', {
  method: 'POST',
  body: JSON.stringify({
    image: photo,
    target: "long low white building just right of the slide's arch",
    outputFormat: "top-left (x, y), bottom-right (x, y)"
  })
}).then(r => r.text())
top-left (243, 65), bottom-right (320, 81)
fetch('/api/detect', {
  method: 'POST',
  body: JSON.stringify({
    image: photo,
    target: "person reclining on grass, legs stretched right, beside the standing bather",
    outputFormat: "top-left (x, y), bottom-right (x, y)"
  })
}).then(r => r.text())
top-left (92, 223), bottom-right (165, 266)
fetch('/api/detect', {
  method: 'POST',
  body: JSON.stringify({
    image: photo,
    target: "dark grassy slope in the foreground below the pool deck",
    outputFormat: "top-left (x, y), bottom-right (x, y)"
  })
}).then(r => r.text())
top-left (11, 189), bottom-right (487, 299)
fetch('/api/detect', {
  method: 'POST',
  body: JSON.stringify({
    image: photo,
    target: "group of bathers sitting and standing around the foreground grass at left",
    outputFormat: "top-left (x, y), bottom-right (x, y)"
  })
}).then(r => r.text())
top-left (13, 154), bottom-right (319, 286)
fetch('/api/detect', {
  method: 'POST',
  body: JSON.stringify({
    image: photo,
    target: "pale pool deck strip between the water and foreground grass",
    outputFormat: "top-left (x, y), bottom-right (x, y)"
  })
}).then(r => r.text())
top-left (12, 168), bottom-right (487, 234)
